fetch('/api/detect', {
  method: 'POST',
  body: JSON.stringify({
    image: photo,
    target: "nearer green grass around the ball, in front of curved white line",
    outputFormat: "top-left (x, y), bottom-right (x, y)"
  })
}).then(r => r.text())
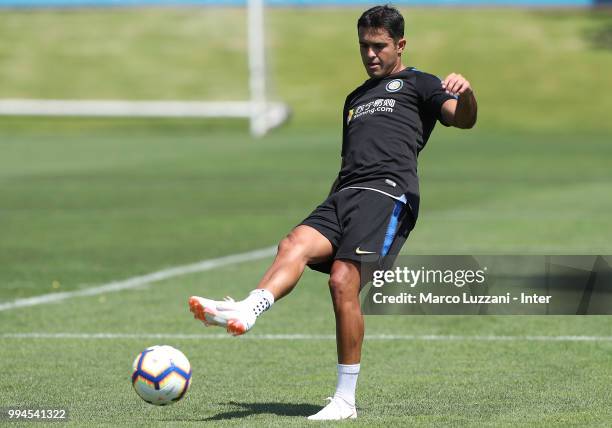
top-left (0, 260), bottom-right (612, 426)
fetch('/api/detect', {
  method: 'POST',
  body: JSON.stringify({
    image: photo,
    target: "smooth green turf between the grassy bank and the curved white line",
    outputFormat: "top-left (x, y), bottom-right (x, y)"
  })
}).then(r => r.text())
top-left (0, 130), bottom-right (612, 299)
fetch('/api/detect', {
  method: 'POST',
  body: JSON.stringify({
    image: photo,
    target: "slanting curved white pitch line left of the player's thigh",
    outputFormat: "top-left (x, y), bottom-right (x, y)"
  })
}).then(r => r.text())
top-left (0, 247), bottom-right (276, 312)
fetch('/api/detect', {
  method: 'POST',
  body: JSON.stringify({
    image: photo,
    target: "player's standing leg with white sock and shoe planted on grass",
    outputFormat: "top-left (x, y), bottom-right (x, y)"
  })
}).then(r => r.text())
top-left (308, 260), bottom-right (364, 420)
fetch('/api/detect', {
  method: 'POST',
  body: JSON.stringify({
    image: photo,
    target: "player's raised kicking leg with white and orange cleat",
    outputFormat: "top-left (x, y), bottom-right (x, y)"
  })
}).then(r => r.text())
top-left (189, 225), bottom-right (333, 335)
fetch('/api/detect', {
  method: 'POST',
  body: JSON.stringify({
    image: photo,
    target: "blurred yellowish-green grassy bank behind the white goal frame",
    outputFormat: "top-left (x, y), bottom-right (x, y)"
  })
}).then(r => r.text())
top-left (0, 8), bottom-right (612, 132)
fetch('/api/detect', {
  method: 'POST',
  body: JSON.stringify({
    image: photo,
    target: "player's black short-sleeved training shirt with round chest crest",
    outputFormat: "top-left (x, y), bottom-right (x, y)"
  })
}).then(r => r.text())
top-left (337, 67), bottom-right (454, 218)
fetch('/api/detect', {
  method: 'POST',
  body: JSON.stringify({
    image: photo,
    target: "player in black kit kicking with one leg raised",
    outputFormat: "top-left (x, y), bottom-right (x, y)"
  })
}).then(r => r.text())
top-left (189, 6), bottom-right (477, 420)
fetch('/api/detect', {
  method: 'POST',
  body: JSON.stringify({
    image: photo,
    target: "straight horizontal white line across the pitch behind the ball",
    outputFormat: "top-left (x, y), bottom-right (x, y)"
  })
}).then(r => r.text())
top-left (0, 333), bottom-right (612, 342)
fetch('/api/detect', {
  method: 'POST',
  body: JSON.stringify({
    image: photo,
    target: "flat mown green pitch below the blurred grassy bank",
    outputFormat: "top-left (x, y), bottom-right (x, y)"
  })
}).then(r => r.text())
top-left (0, 129), bottom-right (612, 426)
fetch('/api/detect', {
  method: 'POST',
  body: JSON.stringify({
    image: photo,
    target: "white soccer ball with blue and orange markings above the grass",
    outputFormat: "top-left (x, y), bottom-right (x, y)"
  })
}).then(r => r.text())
top-left (132, 345), bottom-right (191, 406)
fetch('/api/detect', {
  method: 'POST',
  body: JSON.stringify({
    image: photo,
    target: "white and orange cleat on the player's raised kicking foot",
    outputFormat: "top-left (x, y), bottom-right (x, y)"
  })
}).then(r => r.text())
top-left (189, 296), bottom-right (257, 336)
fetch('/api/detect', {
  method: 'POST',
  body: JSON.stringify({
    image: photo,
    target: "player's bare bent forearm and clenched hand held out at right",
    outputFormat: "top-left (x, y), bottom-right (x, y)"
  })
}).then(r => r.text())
top-left (442, 73), bottom-right (478, 129)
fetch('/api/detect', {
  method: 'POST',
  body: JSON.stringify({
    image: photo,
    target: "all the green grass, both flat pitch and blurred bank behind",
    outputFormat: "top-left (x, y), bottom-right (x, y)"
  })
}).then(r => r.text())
top-left (0, 5), bottom-right (612, 426)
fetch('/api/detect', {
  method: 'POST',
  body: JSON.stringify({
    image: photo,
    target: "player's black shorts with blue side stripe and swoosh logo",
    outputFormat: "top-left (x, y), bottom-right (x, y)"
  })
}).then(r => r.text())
top-left (301, 189), bottom-right (414, 273)
